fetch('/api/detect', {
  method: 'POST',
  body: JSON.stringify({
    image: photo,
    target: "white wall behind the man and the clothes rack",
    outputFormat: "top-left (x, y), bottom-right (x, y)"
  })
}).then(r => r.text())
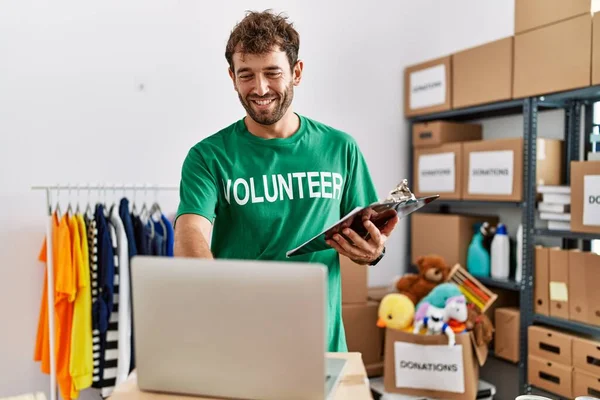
top-left (0, 0), bottom-right (513, 399)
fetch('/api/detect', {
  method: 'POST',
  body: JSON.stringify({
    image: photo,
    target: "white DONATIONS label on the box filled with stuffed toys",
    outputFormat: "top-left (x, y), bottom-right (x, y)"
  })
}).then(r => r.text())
top-left (394, 342), bottom-right (465, 393)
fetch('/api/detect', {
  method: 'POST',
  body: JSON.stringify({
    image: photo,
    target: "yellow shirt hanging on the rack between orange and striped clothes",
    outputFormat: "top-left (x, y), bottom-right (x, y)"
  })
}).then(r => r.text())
top-left (70, 214), bottom-right (94, 399)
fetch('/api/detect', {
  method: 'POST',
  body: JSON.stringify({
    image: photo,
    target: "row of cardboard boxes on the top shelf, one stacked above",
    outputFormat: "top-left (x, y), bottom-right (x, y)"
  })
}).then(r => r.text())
top-left (404, 0), bottom-right (600, 117)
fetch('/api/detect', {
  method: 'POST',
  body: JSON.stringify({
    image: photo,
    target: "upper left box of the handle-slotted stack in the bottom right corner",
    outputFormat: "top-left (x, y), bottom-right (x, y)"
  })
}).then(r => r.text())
top-left (527, 325), bottom-right (573, 366)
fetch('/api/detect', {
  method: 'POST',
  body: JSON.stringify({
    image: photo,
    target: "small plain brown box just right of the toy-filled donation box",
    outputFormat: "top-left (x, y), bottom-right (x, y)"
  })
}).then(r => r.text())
top-left (494, 308), bottom-right (521, 363)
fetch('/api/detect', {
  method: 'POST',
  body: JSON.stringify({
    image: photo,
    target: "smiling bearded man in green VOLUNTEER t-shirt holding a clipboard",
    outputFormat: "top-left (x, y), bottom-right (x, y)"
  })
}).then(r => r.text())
top-left (174, 11), bottom-right (398, 352)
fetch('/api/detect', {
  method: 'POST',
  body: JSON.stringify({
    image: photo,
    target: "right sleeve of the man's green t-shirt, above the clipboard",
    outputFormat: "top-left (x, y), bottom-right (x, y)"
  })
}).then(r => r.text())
top-left (341, 142), bottom-right (378, 216)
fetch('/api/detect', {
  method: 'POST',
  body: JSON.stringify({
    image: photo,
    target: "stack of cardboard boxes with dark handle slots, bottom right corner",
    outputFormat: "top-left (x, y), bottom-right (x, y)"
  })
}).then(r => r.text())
top-left (528, 325), bottom-right (600, 398)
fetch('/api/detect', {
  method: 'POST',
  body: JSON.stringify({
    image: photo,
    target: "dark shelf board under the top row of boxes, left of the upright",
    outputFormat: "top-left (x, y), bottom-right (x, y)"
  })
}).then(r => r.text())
top-left (410, 100), bottom-right (523, 122)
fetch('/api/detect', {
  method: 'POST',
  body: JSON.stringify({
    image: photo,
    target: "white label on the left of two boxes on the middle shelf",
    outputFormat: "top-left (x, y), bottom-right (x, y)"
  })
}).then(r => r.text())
top-left (419, 153), bottom-right (456, 193)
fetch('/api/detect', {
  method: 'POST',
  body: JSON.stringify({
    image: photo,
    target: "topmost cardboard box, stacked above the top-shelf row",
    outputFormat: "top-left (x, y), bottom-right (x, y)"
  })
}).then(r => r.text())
top-left (515, 0), bottom-right (593, 33)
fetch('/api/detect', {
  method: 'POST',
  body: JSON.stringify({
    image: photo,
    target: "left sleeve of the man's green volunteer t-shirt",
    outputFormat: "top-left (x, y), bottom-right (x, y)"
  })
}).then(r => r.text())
top-left (175, 147), bottom-right (218, 223)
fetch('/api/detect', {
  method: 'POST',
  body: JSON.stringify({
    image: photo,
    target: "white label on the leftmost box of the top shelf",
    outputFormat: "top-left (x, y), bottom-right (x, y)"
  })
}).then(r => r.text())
top-left (409, 64), bottom-right (447, 110)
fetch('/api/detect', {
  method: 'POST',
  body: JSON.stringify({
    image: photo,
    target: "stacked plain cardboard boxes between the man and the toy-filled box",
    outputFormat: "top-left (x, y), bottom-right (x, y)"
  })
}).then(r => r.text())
top-left (340, 256), bottom-right (385, 377)
